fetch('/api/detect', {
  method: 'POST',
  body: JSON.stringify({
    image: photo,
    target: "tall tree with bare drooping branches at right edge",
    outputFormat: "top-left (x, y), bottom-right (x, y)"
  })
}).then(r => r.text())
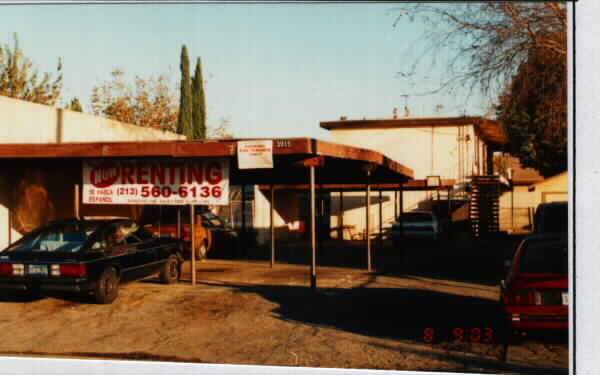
top-left (396, 1), bottom-right (567, 176)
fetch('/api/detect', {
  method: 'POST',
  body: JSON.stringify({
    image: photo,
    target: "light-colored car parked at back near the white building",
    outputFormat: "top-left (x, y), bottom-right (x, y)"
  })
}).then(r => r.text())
top-left (392, 211), bottom-right (440, 245)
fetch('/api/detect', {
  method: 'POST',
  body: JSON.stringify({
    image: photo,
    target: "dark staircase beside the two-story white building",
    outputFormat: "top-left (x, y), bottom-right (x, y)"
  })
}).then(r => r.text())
top-left (469, 176), bottom-right (501, 237)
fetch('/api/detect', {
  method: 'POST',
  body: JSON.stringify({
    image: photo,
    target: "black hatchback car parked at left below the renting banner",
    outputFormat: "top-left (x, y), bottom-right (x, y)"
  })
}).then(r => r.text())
top-left (0, 218), bottom-right (183, 303)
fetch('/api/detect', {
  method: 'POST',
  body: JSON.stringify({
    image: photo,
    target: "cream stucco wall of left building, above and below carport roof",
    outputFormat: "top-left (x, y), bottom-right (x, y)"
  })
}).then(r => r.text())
top-left (0, 96), bottom-right (183, 249)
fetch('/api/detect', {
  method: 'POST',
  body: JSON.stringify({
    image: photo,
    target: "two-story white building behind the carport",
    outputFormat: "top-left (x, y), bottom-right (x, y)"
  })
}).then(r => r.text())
top-left (255, 117), bottom-right (508, 243)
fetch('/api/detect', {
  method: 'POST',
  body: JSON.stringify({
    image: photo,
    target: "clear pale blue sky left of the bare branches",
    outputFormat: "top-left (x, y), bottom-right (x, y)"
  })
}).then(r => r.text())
top-left (0, 4), bottom-right (492, 140)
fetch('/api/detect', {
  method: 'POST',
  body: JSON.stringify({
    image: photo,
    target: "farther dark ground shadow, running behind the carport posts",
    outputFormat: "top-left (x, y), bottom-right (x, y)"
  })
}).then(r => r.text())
top-left (217, 235), bottom-right (522, 286)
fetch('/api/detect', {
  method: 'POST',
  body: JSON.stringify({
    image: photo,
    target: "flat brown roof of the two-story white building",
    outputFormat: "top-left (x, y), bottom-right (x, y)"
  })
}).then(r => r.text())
top-left (320, 116), bottom-right (508, 144)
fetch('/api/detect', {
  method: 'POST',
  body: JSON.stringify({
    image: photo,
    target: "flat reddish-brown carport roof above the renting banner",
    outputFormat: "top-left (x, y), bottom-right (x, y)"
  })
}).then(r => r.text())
top-left (0, 138), bottom-right (414, 184)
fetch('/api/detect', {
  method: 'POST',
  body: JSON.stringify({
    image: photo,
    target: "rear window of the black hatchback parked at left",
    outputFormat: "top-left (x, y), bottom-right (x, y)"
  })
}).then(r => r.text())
top-left (6, 221), bottom-right (98, 253)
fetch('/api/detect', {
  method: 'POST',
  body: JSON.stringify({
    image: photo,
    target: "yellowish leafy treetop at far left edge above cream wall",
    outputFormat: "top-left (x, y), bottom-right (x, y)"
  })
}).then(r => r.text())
top-left (0, 34), bottom-right (62, 105)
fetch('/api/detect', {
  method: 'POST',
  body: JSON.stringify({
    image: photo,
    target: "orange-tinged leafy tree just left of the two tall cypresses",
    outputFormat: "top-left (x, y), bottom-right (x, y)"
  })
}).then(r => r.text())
top-left (91, 69), bottom-right (177, 131)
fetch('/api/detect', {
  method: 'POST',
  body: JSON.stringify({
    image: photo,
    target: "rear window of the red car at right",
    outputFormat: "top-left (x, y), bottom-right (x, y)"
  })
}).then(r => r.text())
top-left (519, 241), bottom-right (568, 274)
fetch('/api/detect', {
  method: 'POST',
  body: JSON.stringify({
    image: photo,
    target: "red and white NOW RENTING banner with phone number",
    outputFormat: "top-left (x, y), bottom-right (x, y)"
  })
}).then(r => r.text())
top-left (83, 159), bottom-right (229, 205)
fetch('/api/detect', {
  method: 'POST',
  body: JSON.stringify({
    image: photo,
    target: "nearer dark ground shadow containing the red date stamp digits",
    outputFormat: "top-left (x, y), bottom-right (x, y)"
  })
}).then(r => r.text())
top-left (196, 283), bottom-right (568, 374)
